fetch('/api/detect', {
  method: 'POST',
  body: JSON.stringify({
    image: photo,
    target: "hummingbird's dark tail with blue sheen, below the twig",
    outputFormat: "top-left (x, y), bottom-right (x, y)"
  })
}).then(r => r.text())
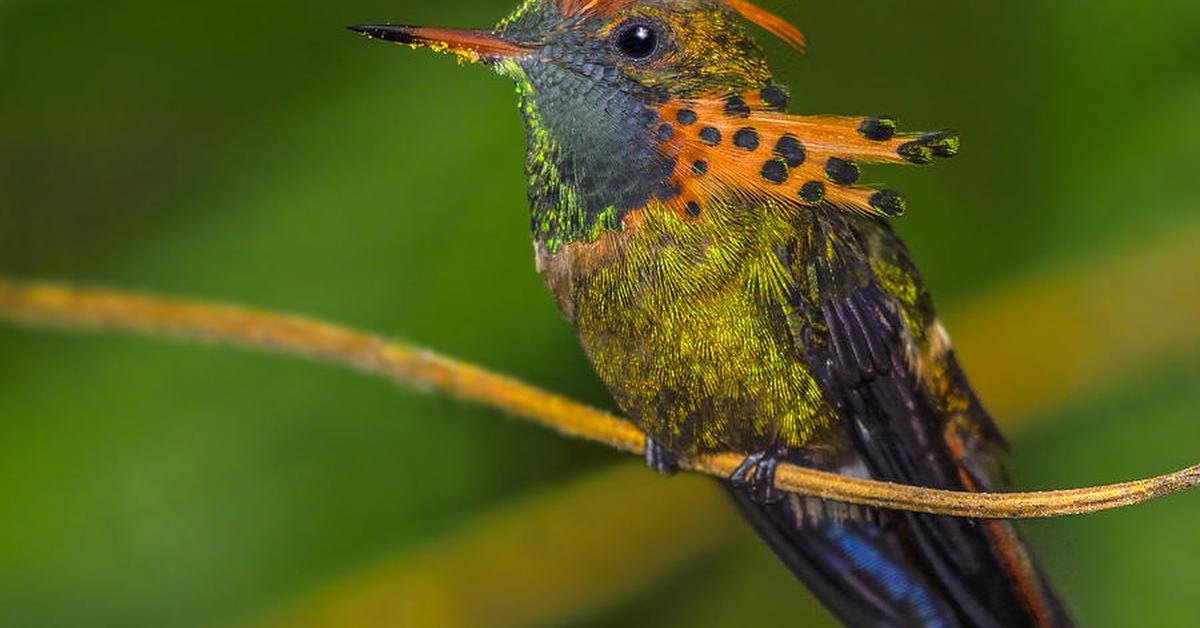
top-left (730, 486), bottom-right (1072, 628)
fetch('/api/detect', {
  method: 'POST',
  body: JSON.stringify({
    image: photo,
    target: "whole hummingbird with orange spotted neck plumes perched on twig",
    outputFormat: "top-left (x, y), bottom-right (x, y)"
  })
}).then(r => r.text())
top-left (350, 0), bottom-right (1072, 627)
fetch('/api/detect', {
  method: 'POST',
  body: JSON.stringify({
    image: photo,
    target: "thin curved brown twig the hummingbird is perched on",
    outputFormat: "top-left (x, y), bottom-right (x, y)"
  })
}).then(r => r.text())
top-left (0, 279), bottom-right (1200, 519)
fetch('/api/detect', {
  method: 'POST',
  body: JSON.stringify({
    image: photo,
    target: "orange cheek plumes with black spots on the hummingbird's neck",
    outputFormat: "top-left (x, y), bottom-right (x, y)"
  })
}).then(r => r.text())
top-left (658, 92), bottom-right (959, 217)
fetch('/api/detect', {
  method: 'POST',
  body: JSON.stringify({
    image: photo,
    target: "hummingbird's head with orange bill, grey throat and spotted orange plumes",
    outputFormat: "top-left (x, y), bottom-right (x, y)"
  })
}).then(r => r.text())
top-left (352, 0), bottom-right (958, 250)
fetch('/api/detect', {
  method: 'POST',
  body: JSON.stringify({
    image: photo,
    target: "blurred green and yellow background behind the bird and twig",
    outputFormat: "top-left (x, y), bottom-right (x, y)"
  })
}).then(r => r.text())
top-left (0, 0), bottom-right (1200, 628)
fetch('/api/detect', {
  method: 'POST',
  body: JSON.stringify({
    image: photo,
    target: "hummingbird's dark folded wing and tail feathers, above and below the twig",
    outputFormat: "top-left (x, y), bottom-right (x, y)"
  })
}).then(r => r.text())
top-left (739, 208), bottom-right (1070, 627)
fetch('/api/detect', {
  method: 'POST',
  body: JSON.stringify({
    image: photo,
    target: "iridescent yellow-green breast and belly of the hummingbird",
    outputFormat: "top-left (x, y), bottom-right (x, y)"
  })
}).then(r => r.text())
top-left (539, 194), bottom-right (835, 454)
